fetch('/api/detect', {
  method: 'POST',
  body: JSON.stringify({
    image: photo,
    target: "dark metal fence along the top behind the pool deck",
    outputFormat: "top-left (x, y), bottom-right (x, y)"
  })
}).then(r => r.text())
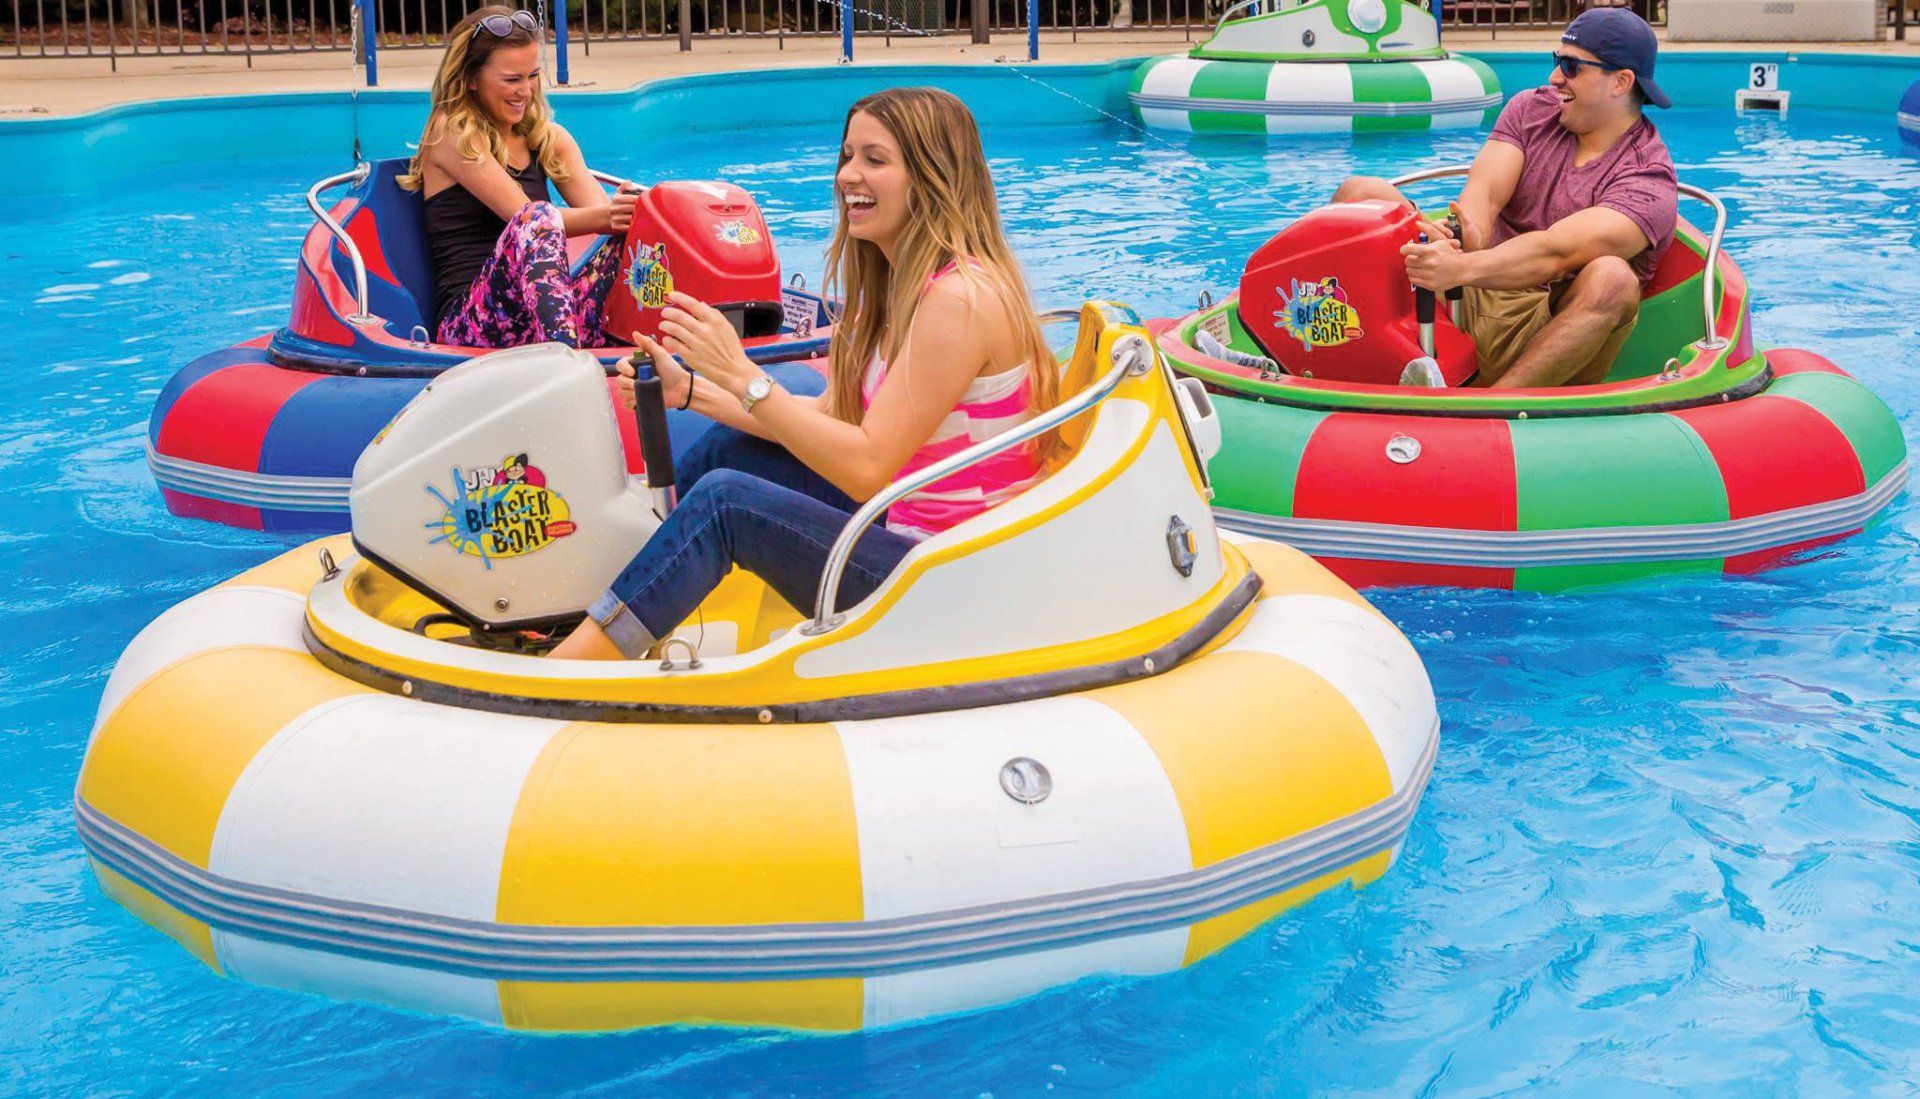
top-left (18, 0), bottom-right (1920, 58)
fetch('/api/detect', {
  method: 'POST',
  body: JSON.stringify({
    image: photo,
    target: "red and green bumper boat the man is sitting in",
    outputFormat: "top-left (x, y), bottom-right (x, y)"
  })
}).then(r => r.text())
top-left (1156, 169), bottom-right (1907, 590)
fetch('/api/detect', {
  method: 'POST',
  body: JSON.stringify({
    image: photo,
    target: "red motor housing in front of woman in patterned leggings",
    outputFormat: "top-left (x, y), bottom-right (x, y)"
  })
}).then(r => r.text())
top-left (607, 181), bottom-right (781, 342)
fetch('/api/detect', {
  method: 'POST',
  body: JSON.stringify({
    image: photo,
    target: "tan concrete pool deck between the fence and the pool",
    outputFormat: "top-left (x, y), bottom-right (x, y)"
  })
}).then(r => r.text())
top-left (0, 27), bottom-right (1920, 119)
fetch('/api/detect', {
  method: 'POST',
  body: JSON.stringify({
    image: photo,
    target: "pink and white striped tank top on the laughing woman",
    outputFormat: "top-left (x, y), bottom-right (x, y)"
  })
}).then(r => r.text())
top-left (860, 263), bottom-right (1041, 542)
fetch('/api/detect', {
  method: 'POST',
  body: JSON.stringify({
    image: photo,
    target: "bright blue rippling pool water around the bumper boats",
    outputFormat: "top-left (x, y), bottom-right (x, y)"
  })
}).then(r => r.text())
top-left (0, 68), bottom-right (1920, 1095)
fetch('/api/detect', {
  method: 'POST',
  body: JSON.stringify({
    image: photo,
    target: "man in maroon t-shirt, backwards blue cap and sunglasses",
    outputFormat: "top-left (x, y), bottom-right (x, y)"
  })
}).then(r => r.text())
top-left (1332, 8), bottom-right (1678, 386)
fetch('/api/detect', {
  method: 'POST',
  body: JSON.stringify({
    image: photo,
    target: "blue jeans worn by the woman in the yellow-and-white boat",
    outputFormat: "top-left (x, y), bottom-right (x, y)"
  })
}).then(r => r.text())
top-left (588, 425), bottom-right (914, 659)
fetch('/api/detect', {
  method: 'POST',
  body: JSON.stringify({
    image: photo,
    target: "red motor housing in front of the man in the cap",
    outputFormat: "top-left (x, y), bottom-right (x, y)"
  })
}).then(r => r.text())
top-left (1240, 202), bottom-right (1478, 386)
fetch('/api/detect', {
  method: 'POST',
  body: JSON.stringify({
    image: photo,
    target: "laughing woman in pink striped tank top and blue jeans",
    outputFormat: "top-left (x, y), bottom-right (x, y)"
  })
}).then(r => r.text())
top-left (553, 88), bottom-right (1060, 659)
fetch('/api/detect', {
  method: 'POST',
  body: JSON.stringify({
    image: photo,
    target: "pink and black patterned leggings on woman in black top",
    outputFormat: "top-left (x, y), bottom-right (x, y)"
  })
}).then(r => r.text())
top-left (440, 202), bottom-right (624, 348)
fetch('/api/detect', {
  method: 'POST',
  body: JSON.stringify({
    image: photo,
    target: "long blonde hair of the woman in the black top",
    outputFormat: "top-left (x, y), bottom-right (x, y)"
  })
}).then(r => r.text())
top-left (397, 4), bottom-right (566, 190)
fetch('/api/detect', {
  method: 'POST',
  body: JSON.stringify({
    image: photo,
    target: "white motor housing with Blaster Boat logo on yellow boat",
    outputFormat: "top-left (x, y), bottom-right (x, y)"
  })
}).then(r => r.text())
top-left (349, 344), bottom-right (660, 630)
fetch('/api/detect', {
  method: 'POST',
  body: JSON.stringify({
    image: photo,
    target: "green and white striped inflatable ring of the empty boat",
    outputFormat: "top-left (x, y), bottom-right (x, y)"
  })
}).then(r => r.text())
top-left (1127, 56), bottom-right (1501, 134)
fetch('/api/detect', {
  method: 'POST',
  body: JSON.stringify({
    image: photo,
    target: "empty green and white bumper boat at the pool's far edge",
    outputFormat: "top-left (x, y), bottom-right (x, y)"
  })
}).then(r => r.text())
top-left (1129, 0), bottom-right (1501, 134)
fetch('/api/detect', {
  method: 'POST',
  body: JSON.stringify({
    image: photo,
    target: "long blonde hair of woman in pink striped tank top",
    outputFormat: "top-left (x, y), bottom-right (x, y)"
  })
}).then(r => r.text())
top-left (826, 88), bottom-right (1062, 463)
